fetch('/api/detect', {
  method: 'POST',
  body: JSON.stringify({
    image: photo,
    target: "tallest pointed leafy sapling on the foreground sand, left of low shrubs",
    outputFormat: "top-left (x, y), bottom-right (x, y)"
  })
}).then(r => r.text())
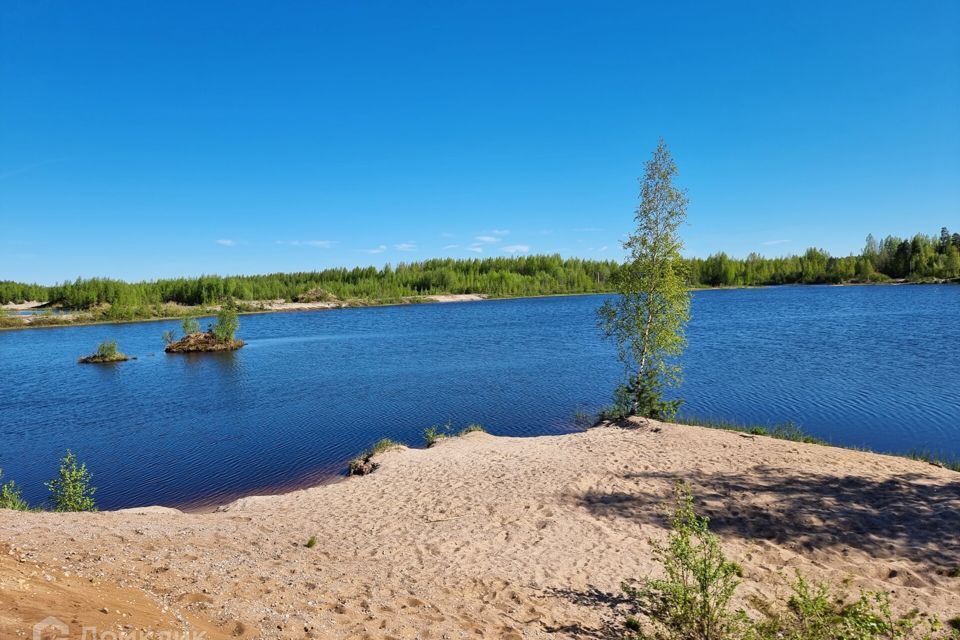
top-left (623, 482), bottom-right (747, 640)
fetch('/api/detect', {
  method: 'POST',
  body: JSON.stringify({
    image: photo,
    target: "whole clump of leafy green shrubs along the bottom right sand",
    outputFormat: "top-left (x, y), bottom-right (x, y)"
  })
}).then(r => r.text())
top-left (623, 483), bottom-right (960, 640)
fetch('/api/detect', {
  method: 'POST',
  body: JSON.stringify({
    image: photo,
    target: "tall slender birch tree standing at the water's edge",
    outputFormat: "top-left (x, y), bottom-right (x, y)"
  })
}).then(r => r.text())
top-left (598, 140), bottom-right (690, 417)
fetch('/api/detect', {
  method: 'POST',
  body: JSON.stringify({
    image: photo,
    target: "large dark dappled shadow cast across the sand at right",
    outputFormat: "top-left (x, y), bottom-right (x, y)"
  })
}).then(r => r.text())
top-left (580, 466), bottom-right (960, 571)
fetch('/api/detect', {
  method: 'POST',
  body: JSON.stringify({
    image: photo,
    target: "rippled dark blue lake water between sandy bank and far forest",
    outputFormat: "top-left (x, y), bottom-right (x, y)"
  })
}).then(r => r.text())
top-left (0, 285), bottom-right (960, 509)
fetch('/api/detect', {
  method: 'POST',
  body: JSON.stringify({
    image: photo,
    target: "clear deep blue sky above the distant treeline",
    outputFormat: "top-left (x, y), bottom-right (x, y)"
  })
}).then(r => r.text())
top-left (0, 0), bottom-right (960, 283)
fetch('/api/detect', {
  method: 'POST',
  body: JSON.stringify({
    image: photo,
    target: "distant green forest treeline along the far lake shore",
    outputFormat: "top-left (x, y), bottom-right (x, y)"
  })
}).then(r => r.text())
top-left (0, 228), bottom-right (960, 318)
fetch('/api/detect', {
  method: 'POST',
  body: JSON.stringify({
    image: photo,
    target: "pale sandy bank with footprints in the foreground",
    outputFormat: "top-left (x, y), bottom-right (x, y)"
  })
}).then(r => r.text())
top-left (0, 423), bottom-right (960, 638)
